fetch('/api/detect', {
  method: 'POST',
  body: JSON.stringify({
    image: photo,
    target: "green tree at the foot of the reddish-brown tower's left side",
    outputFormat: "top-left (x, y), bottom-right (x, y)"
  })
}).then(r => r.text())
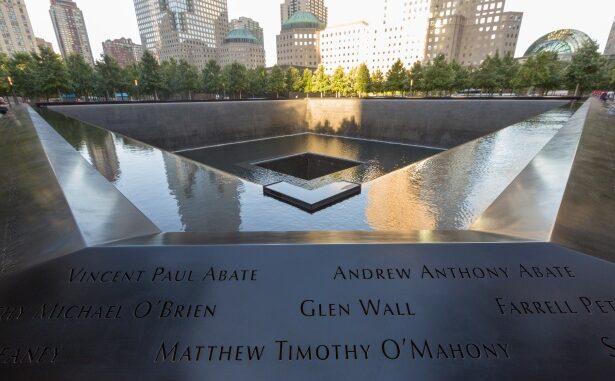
top-left (33, 47), bottom-right (71, 98)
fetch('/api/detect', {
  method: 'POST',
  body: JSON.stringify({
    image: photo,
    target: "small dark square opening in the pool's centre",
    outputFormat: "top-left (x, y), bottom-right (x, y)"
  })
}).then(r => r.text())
top-left (254, 153), bottom-right (362, 180)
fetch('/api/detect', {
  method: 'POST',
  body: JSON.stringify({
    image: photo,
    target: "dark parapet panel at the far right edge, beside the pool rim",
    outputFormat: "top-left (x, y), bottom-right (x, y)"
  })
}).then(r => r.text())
top-left (551, 99), bottom-right (615, 262)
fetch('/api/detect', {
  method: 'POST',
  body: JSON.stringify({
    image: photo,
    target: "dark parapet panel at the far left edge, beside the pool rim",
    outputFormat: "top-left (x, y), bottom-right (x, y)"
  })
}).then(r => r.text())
top-left (0, 106), bottom-right (86, 274)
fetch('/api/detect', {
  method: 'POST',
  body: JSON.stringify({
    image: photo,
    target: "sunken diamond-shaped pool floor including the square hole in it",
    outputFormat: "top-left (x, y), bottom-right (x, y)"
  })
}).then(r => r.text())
top-left (176, 133), bottom-right (443, 189)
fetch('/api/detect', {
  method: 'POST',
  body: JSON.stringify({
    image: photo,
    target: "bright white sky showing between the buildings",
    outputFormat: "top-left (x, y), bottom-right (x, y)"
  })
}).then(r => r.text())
top-left (25, 0), bottom-right (615, 66)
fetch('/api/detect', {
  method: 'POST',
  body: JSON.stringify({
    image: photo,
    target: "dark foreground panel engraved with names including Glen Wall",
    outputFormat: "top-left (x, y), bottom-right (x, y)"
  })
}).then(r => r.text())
top-left (0, 244), bottom-right (615, 381)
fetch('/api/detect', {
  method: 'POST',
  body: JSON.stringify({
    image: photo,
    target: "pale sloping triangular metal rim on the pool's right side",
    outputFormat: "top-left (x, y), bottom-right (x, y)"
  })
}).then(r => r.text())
top-left (472, 103), bottom-right (590, 241)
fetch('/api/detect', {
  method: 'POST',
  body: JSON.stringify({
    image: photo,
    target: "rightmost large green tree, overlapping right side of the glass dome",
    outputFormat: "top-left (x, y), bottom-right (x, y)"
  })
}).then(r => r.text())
top-left (565, 41), bottom-right (606, 96)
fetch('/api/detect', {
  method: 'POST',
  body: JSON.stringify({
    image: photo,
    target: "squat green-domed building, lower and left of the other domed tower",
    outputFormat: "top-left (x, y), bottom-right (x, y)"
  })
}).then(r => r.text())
top-left (218, 28), bottom-right (265, 69)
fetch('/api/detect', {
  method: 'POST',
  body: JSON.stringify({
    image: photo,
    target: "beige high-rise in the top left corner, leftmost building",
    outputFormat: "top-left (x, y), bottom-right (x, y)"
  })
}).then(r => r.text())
top-left (0, 0), bottom-right (37, 55)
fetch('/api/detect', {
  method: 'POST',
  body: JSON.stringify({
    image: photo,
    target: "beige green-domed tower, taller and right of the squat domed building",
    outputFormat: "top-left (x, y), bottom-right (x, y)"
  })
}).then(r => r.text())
top-left (276, 11), bottom-right (324, 69)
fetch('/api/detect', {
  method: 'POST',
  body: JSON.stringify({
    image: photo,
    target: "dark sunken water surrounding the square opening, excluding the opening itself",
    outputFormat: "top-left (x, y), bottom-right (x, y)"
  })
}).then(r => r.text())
top-left (178, 134), bottom-right (442, 189)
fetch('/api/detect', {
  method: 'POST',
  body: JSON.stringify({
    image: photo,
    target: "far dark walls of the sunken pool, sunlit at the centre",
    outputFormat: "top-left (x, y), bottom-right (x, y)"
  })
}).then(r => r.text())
top-left (49, 99), bottom-right (569, 151)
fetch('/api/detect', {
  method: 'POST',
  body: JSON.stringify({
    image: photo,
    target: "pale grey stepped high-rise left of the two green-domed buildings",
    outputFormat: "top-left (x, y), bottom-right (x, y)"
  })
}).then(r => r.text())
top-left (134, 0), bottom-right (229, 66)
